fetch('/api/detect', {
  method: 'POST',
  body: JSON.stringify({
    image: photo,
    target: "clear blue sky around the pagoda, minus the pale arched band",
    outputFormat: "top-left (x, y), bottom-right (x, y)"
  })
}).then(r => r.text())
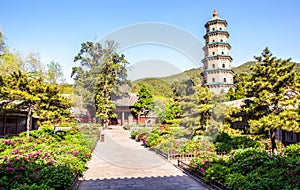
top-left (0, 0), bottom-right (300, 82)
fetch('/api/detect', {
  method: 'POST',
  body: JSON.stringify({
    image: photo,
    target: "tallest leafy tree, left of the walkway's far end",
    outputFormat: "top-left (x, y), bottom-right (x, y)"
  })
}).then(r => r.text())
top-left (71, 40), bottom-right (127, 124)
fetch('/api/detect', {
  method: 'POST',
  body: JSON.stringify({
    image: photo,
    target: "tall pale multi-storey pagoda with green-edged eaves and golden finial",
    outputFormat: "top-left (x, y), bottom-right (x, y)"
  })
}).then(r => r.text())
top-left (202, 10), bottom-right (233, 94)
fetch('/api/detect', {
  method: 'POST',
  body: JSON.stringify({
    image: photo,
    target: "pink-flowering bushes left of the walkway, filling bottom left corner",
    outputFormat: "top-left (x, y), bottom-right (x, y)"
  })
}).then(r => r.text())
top-left (0, 122), bottom-right (99, 189)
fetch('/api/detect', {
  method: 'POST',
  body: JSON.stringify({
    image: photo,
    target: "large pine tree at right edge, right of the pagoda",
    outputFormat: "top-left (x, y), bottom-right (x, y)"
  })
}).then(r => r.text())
top-left (245, 48), bottom-right (300, 152)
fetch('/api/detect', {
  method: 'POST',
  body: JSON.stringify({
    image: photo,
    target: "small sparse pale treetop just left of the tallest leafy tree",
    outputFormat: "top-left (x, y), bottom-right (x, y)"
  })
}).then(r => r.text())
top-left (47, 61), bottom-right (66, 84)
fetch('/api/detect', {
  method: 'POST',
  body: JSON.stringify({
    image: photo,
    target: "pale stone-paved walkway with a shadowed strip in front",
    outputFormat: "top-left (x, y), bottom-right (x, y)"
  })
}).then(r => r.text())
top-left (79, 127), bottom-right (206, 190)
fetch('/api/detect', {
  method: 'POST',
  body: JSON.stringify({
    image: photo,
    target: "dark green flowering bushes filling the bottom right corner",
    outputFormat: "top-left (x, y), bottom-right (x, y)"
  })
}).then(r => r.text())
top-left (190, 145), bottom-right (300, 189)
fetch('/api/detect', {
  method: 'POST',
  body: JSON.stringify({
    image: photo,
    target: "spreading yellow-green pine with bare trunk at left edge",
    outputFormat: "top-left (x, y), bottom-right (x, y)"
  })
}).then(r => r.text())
top-left (0, 71), bottom-right (70, 136)
